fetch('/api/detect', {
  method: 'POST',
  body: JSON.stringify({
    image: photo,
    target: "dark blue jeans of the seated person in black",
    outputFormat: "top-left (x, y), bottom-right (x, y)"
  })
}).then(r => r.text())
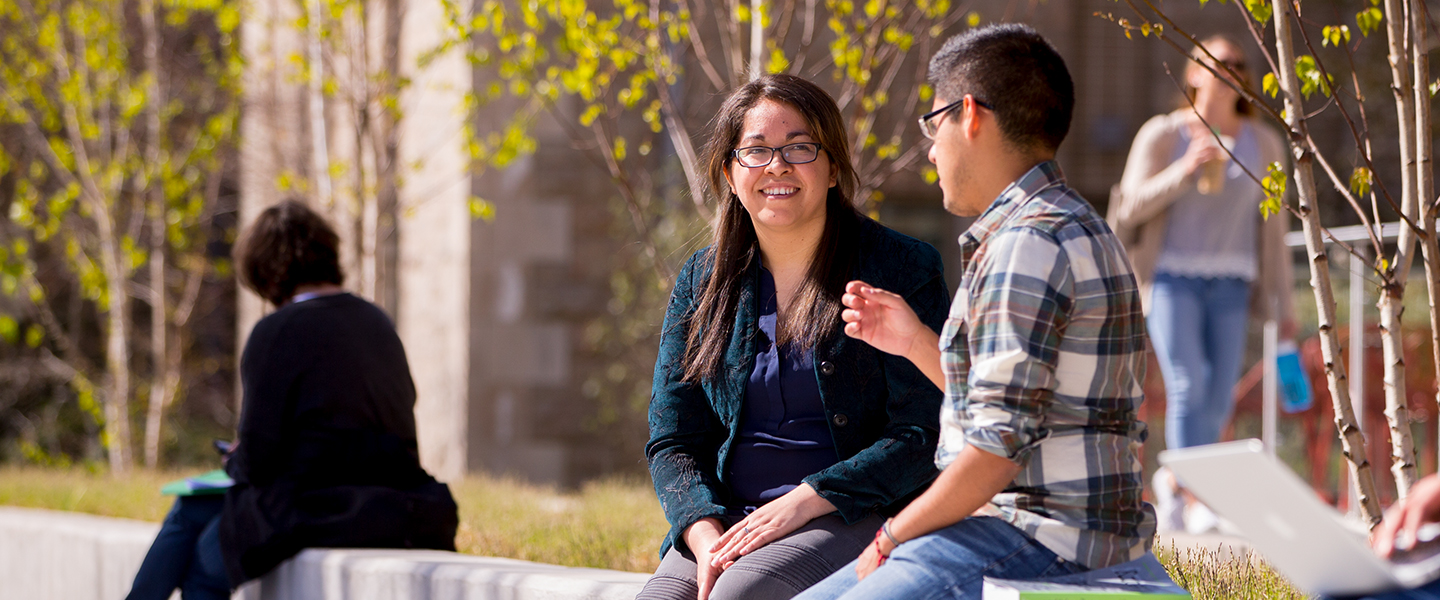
top-left (125, 494), bottom-right (230, 600)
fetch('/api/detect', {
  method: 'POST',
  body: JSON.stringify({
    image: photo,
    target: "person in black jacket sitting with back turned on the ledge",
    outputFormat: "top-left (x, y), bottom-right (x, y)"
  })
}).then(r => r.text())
top-left (130, 200), bottom-right (458, 600)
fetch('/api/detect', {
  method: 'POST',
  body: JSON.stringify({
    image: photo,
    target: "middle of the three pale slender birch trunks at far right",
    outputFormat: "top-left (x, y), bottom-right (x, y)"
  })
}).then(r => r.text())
top-left (1378, 0), bottom-right (1418, 498)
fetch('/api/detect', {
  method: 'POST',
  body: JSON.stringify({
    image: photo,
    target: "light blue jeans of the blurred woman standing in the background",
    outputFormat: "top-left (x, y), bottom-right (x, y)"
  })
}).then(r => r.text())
top-left (1146, 273), bottom-right (1250, 447)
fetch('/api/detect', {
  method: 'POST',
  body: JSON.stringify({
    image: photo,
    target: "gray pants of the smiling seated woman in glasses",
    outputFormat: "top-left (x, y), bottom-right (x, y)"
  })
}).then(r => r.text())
top-left (635, 515), bottom-right (884, 600)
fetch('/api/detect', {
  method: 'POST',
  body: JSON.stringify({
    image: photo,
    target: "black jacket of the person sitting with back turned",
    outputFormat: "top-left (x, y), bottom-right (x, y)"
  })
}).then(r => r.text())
top-left (220, 294), bottom-right (458, 586)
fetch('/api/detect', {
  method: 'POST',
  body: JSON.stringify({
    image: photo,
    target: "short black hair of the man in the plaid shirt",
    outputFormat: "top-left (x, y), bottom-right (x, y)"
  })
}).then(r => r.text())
top-left (929, 23), bottom-right (1076, 151)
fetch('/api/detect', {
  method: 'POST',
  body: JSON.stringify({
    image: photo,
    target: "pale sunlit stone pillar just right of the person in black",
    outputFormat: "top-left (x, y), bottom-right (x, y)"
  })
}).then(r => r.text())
top-left (395, 0), bottom-right (472, 481)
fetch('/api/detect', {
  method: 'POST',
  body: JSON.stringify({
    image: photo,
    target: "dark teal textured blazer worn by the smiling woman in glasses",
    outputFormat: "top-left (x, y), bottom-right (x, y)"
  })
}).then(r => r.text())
top-left (645, 219), bottom-right (950, 557)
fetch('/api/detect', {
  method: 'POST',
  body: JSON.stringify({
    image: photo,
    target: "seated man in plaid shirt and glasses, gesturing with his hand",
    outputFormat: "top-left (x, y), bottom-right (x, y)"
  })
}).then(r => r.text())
top-left (801, 24), bottom-right (1155, 600)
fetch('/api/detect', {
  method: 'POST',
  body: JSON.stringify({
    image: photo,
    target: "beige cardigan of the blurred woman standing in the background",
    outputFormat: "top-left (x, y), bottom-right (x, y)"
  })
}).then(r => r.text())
top-left (1106, 109), bottom-right (1295, 324)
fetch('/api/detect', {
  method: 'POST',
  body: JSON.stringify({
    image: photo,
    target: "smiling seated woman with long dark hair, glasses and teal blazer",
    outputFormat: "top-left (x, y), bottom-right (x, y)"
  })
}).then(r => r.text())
top-left (639, 75), bottom-right (949, 600)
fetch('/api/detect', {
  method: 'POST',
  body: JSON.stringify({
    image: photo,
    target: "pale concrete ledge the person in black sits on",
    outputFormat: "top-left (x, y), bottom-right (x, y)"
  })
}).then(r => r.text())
top-left (0, 506), bottom-right (648, 600)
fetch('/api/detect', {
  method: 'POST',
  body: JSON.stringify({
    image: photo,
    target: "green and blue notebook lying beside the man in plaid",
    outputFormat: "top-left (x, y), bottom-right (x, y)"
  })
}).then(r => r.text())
top-left (985, 554), bottom-right (1189, 600)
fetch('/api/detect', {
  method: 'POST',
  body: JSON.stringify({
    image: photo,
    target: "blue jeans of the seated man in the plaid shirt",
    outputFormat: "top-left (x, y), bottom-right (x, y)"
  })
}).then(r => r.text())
top-left (795, 517), bottom-right (1084, 600)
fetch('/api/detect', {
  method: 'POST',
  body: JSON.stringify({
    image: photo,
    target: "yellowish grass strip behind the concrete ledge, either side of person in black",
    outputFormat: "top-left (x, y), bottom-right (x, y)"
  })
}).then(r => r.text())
top-left (0, 466), bottom-right (670, 573)
